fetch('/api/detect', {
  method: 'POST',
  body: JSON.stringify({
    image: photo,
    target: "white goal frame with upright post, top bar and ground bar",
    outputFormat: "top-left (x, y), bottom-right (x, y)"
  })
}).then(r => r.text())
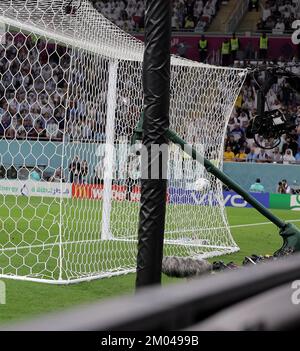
top-left (0, 0), bottom-right (244, 284)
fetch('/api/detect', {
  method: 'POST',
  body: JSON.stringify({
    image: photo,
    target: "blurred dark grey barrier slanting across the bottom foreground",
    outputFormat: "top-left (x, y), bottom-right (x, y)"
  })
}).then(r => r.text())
top-left (1, 254), bottom-right (300, 331)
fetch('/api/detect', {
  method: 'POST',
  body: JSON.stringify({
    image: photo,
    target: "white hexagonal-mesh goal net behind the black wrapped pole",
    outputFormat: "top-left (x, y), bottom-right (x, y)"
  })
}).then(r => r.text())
top-left (0, 0), bottom-right (245, 284)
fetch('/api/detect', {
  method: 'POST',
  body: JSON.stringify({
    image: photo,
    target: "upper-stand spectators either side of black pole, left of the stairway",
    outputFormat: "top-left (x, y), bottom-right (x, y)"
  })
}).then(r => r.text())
top-left (93, 0), bottom-right (220, 32)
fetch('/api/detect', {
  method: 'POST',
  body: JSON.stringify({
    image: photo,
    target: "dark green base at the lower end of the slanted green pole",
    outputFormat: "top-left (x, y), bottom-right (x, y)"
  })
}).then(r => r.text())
top-left (274, 223), bottom-right (300, 256)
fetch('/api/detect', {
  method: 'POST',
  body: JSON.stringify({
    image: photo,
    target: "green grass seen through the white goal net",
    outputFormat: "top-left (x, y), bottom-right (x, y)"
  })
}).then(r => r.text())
top-left (0, 196), bottom-right (241, 280)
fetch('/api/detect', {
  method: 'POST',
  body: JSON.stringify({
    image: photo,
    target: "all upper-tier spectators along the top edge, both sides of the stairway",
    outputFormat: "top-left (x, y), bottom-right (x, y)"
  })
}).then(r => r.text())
top-left (93, 0), bottom-right (300, 33)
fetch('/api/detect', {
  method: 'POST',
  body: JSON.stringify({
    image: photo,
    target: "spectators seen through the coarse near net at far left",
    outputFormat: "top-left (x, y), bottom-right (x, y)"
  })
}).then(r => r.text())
top-left (0, 34), bottom-right (70, 139)
